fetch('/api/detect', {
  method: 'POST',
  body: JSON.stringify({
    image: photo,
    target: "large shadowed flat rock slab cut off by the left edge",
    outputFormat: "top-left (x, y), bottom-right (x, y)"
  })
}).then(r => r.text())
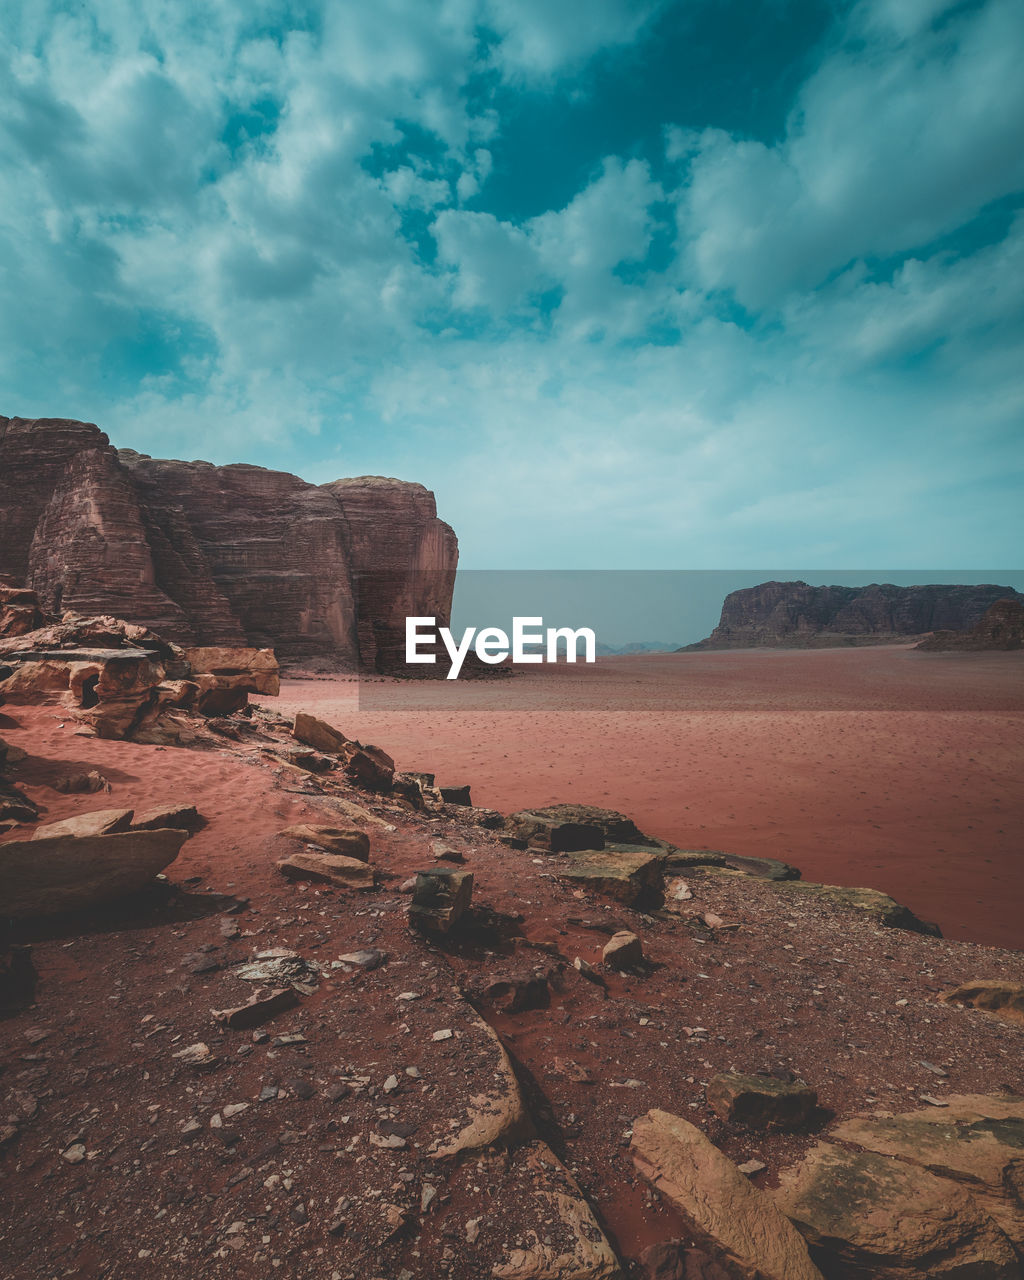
top-left (0, 831), bottom-right (188, 919)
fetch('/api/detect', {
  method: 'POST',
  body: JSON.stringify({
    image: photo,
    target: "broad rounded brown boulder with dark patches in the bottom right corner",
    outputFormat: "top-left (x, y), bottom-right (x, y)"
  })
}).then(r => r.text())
top-left (774, 1142), bottom-right (1020, 1280)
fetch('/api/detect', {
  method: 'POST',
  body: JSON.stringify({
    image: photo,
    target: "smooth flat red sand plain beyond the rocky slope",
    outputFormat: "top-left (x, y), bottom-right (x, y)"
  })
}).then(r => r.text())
top-left (268, 648), bottom-right (1024, 947)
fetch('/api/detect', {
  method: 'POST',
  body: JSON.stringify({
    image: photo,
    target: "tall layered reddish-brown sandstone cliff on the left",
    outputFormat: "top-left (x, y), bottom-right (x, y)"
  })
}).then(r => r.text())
top-left (0, 417), bottom-right (458, 671)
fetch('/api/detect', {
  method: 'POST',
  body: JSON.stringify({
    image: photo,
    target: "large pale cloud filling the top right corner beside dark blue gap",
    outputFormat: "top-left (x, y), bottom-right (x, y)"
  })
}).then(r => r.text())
top-left (669, 0), bottom-right (1024, 310)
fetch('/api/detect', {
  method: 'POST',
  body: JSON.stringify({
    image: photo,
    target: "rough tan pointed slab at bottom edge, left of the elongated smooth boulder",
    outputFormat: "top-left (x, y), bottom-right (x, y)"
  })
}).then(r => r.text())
top-left (490, 1139), bottom-right (622, 1280)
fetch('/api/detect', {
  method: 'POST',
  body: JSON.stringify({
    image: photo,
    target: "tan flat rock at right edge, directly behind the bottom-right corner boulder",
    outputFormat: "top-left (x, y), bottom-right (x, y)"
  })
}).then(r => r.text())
top-left (832, 1094), bottom-right (1024, 1254)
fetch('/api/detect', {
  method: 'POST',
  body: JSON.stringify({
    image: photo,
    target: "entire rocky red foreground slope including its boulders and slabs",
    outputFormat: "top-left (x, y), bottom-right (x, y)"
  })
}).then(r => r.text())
top-left (0, 604), bottom-right (1024, 1280)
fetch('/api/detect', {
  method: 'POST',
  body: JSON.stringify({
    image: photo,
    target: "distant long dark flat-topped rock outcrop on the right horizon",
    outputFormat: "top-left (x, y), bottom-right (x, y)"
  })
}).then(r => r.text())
top-left (681, 582), bottom-right (1024, 652)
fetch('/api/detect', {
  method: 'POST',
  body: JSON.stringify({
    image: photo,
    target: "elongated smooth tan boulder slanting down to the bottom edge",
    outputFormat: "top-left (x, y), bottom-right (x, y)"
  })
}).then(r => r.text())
top-left (630, 1111), bottom-right (822, 1280)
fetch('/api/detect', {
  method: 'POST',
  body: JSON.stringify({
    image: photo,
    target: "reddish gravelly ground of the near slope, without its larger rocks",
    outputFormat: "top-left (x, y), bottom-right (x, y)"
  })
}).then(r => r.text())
top-left (0, 707), bottom-right (1024, 1280)
